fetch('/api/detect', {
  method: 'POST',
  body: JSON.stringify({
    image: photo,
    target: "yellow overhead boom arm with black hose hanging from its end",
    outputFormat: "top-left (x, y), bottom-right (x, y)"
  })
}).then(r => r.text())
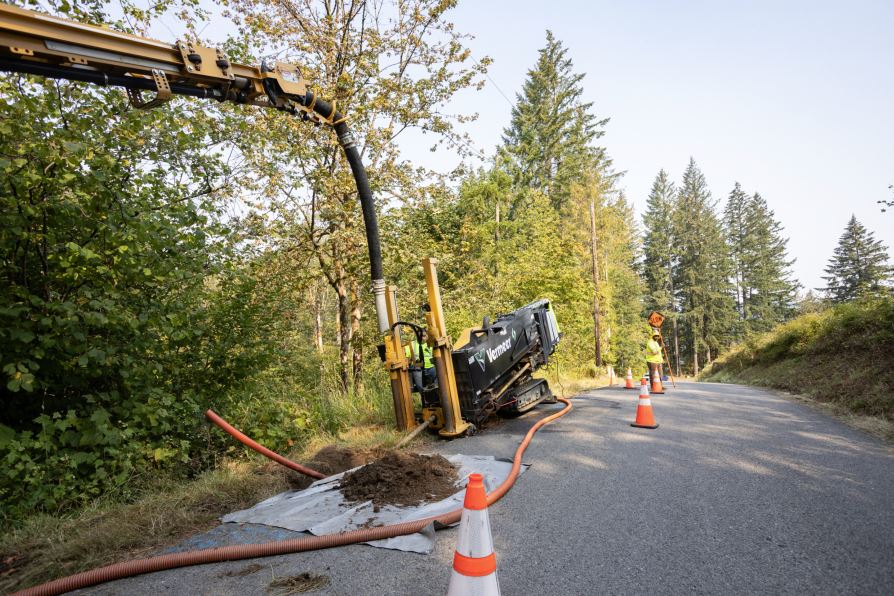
top-left (0, 4), bottom-right (388, 340)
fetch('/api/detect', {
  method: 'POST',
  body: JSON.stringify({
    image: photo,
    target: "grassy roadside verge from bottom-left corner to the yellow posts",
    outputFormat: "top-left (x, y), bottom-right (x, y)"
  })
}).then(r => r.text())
top-left (0, 366), bottom-right (403, 594)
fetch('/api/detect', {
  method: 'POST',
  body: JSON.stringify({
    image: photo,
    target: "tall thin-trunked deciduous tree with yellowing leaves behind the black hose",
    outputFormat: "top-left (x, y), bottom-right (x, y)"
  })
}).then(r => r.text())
top-left (230, 0), bottom-right (489, 393)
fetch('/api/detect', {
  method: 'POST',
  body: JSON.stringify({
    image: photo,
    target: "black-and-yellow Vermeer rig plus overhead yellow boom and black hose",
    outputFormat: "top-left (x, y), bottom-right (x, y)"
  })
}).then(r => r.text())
top-left (0, 4), bottom-right (560, 438)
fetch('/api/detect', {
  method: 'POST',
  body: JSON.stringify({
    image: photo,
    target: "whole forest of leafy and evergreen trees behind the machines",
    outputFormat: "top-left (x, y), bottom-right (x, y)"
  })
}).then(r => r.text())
top-left (0, 0), bottom-right (891, 523)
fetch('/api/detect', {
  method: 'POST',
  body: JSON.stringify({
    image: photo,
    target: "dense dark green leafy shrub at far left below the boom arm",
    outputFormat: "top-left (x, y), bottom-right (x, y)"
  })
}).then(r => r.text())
top-left (0, 66), bottom-right (281, 515)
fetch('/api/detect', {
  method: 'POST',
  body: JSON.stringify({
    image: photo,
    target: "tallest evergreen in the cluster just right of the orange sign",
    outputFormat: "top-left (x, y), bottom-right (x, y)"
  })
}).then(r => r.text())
top-left (673, 158), bottom-right (735, 374)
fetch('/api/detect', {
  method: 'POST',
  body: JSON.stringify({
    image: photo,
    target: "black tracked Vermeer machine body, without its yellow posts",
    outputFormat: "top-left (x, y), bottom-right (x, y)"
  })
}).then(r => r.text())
top-left (453, 300), bottom-right (560, 424)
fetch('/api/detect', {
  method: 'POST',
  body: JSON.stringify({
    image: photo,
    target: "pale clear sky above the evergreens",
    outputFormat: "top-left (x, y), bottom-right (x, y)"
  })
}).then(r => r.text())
top-left (407, 0), bottom-right (894, 288)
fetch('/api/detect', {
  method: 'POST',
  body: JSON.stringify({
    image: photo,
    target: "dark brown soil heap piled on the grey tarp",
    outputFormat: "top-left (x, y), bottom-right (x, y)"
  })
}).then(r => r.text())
top-left (341, 451), bottom-right (458, 507)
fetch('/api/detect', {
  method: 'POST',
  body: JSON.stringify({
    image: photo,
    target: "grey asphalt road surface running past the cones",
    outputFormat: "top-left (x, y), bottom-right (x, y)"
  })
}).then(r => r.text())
top-left (82, 383), bottom-right (894, 596)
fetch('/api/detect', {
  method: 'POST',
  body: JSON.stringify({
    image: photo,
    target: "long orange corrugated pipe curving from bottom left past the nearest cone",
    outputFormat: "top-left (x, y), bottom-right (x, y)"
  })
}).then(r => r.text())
top-left (13, 398), bottom-right (572, 596)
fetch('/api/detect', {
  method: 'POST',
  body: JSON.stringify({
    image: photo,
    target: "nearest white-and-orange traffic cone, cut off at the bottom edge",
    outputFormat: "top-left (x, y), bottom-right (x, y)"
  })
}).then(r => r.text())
top-left (447, 474), bottom-right (500, 596)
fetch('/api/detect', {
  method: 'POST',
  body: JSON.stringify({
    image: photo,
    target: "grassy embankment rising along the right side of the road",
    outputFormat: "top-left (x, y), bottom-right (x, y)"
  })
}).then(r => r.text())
top-left (700, 298), bottom-right (894, 422)
